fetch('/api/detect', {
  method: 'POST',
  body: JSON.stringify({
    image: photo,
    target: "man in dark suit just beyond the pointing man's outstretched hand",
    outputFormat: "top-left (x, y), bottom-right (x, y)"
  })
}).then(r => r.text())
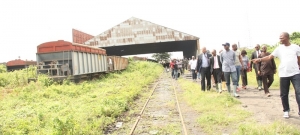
top-left (250, 44), bottom-right (262, 90)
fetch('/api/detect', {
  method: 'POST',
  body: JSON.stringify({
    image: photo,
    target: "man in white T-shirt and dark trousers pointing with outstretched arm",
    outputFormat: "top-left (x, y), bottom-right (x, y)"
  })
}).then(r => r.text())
top-left (253, 32), bottom-right (300, 118)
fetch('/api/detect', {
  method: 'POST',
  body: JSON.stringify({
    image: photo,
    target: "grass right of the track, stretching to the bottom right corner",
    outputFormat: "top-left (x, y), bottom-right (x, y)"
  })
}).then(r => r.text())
top-left (178, 79), bottom-right (300, 135)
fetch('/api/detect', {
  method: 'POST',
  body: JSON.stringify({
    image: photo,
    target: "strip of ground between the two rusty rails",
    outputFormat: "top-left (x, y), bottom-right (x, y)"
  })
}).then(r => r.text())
top-left (134, 74), bottom-right (182, 135)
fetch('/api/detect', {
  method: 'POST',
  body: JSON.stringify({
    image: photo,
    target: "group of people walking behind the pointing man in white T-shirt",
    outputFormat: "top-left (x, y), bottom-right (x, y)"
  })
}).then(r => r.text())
top-left (185, 40), bottom-right (276, 97)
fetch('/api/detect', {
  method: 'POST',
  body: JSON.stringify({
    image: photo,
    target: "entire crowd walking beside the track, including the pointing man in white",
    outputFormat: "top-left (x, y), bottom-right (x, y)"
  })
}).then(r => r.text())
top-left (165, 32), bottom-right (300, 118)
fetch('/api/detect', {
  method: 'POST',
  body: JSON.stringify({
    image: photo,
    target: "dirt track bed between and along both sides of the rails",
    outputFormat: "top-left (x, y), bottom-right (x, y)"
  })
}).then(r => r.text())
top-left (107, 73), bottom-right (204, 135)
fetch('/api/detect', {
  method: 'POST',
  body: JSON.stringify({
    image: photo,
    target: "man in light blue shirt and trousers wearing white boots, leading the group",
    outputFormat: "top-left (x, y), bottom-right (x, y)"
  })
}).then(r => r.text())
top-left (221, 43), bottom-right (239, 97)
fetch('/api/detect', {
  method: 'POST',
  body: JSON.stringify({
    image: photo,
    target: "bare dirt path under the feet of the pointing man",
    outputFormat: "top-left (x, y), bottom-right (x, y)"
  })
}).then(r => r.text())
top-left (238, 87), bottom-right (300, 128)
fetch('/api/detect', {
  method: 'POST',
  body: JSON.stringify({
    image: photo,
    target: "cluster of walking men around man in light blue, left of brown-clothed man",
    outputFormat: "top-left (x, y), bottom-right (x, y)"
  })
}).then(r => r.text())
top-left (190, 43), bottom-right (249, 97)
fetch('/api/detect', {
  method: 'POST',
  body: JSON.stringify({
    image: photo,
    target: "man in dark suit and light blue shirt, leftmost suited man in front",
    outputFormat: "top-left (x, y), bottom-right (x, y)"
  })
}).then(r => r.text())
top-left (196, 47), bottom-right (211, 91)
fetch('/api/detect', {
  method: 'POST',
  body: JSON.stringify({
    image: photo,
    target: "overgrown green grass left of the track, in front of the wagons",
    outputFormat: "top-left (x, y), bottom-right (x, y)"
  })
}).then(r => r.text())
top-left (0, 62), bottom-right (163, 135)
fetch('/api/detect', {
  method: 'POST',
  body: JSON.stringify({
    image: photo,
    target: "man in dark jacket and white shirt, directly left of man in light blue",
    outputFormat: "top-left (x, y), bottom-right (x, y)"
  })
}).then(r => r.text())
top-left (209, 49), bottom-right (222, 93)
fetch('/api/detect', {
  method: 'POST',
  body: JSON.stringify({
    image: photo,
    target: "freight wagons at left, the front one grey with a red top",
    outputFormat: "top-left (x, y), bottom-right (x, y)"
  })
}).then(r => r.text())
top-left (29, 40), bottom-right (128, 82)
